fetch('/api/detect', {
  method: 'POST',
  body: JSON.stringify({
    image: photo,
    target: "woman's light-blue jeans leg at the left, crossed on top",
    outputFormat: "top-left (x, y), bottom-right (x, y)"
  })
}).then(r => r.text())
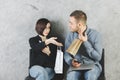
top-left (30, 65), bottom-right (50, 80)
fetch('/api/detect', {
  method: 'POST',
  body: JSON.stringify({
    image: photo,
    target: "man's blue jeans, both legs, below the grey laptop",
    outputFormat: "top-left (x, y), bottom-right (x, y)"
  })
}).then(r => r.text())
top-left (67, 66), bottom-right (101, 80)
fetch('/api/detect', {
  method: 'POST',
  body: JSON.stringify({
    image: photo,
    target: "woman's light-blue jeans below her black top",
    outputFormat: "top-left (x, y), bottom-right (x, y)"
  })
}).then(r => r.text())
top-left (30, 65), bottom-right (55, 80)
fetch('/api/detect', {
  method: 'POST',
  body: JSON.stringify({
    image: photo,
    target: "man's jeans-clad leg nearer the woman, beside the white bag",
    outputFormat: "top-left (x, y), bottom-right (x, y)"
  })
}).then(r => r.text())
top-left (67, 71), bottom-right (80, 80)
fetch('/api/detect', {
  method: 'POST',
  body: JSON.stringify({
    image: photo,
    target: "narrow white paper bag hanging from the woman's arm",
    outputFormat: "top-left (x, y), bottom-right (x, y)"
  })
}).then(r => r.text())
top-left (54, 47), bottom-right (63, 74)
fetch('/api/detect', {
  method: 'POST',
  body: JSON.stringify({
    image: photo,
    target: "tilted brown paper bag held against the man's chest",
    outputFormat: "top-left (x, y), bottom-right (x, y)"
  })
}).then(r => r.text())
top-left (66, 39), bottom-right (82, 56)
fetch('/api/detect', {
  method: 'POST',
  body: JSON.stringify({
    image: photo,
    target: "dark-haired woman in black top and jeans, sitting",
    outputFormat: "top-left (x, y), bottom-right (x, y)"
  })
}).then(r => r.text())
top-left (29, 18), bottom-right (62, 80)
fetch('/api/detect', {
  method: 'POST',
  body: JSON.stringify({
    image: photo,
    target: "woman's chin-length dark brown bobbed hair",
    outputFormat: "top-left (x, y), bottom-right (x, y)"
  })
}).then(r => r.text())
top-left (35, 18), bottom-right (50, 35)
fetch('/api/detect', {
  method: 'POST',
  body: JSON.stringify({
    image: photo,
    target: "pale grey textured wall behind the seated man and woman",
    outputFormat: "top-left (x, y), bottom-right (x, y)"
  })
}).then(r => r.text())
top-left (0, 0), bottom-right (120, 80)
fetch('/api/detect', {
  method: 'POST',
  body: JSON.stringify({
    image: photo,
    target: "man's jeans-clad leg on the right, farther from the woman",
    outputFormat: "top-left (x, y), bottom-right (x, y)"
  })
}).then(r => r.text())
top-left (84, 66), bottom-right (101, 80)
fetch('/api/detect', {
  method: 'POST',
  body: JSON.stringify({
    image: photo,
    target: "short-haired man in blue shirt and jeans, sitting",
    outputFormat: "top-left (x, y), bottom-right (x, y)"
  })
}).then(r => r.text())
top-left (64, 10), bottom-right (102, 80)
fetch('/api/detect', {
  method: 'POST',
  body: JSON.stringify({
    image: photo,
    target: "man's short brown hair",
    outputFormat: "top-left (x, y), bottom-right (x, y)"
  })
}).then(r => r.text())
top-left (70, 10), bottom-right (87, 24)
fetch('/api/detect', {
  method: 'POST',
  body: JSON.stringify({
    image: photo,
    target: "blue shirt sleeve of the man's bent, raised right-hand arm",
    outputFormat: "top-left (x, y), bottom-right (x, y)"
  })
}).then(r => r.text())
top-left (83, 32), bottom-right (102, 61)
